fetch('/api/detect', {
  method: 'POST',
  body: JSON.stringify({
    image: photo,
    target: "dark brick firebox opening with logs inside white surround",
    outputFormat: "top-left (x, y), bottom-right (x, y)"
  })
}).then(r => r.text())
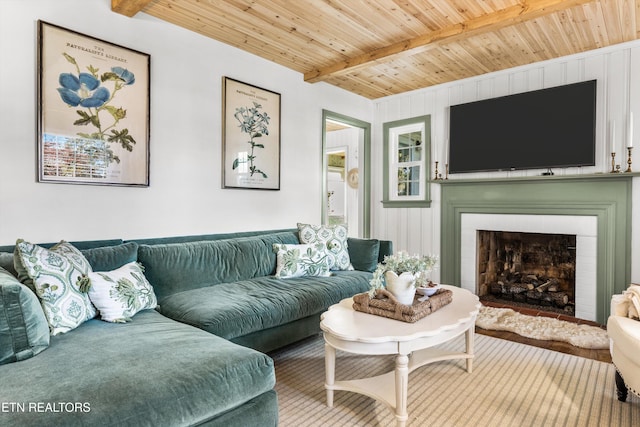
top-left (476, 230), bottom-right (576, 316)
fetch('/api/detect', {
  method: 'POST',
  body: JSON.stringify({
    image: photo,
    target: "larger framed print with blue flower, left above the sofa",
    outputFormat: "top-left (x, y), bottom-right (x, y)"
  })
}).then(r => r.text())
top-left (37, 21), bottom-right (150, 186)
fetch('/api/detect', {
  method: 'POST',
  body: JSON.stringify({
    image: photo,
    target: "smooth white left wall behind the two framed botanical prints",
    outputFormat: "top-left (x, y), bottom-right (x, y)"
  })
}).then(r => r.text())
top-left (0, 0), bottom-right (373, 245)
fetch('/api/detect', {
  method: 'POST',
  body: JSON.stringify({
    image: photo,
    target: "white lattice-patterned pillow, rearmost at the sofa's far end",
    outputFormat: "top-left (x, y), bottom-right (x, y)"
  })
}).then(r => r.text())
top-left (298, 223), bottom-right (353, 270)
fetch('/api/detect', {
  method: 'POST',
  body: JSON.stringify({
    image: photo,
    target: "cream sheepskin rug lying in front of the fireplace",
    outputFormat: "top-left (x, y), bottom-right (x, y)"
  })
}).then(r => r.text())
top-left (476, 306), bottom-right (609, 349)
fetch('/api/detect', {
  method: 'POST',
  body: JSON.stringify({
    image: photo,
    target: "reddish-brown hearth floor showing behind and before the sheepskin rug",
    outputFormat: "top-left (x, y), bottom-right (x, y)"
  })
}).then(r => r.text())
top-left (476, 302), bottom-right (611, 363)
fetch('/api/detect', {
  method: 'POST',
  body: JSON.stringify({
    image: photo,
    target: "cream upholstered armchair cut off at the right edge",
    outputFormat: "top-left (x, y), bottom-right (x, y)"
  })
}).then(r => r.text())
top-left (607, 285), bottom-right (640, 402)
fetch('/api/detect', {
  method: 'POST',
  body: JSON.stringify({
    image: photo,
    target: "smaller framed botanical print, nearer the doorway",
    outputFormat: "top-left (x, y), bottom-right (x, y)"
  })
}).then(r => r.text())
top-left (222, 77), bottom-right (281, 190)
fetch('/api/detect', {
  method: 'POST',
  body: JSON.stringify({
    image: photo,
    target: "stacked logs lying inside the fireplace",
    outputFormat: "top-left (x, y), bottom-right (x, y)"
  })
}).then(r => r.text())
top-left (489, 272), bottom-right (574, 312)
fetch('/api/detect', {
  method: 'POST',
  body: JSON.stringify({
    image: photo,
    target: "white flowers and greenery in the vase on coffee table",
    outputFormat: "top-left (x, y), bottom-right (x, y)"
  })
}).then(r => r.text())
top-left (369, 251), bottom-right (438, 298)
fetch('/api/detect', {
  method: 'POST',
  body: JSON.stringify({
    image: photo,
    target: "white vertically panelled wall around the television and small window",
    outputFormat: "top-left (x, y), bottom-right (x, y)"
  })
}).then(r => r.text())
top-left (371, 41), bottom-right (640, 282)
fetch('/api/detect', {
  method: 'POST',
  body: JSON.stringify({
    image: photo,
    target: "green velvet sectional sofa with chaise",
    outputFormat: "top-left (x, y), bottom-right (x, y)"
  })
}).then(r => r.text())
top-left (0, 229), bottom-right (392, 427)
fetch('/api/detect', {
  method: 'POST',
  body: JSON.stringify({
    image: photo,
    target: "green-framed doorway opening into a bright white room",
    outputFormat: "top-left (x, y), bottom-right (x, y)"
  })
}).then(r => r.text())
top-left (322, 110), bottom-right (371, 238)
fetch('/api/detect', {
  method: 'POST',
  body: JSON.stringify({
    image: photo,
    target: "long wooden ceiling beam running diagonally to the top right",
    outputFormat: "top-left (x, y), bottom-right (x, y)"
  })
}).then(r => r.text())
top-left (304, 0), bottom-right (595, 83)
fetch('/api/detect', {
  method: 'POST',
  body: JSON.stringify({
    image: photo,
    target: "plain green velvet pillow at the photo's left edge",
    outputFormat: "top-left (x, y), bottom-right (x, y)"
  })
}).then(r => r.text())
top-left (0, 268), bottom-right (49, 365)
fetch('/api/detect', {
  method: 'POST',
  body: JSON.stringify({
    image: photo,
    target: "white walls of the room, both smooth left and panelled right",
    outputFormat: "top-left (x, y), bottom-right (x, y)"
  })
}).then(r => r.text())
top-left (0, 0), bottom-right (640, 282)
